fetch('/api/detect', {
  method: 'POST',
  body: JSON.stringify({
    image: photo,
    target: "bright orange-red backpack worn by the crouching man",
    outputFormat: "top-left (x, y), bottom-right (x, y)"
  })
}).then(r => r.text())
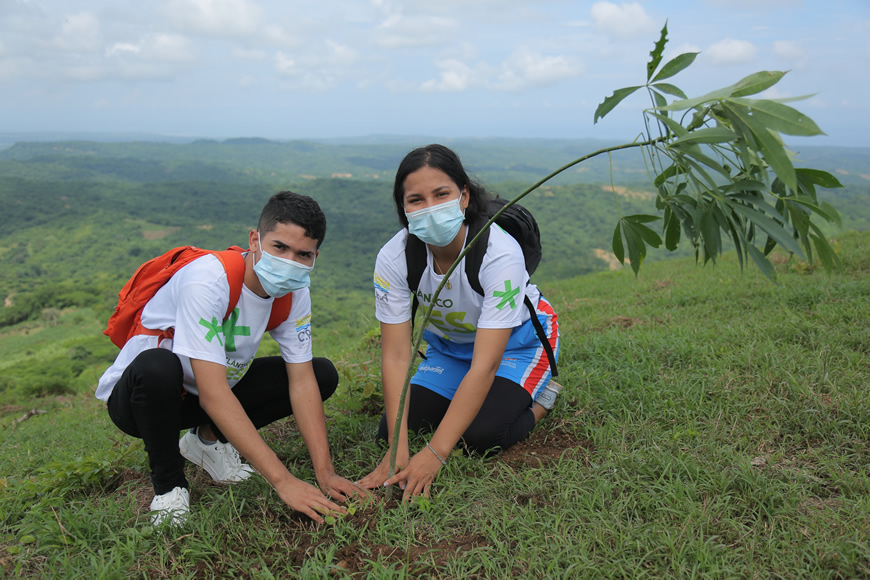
top-left (103, 246), bottom-right (293, 348)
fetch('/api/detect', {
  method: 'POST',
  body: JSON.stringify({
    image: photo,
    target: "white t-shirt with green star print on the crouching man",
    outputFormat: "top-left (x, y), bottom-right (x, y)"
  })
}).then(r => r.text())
top-left (96, 256), bottom-right (312, 401)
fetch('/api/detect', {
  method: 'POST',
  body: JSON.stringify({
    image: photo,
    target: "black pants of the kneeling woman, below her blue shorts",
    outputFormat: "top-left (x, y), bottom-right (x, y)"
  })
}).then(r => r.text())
top-left (378, 377), bottom-right (535, 453)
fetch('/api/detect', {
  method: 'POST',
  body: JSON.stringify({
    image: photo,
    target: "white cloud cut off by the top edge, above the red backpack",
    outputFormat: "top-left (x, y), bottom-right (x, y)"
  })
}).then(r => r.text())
top-left (163, 0), bottom-right (263, 37)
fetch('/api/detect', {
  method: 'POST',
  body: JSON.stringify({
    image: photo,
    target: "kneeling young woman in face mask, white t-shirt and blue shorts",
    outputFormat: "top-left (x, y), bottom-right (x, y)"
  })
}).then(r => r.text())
top-left (360, 145), bottom-right (561, 499)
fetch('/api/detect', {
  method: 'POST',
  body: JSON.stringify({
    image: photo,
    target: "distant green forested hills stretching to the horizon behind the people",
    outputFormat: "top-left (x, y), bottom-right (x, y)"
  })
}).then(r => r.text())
top-left (0, 139), bottom-right (870, 342)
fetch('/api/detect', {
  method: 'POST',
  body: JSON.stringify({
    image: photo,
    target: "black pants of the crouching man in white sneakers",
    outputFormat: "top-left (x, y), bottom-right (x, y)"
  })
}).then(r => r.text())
top-left (108, 348), bottom-right (338, 495)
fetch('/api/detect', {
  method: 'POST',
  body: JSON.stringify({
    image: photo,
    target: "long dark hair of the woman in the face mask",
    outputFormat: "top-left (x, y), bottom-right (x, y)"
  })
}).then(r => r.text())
top-left (393, 144), bottom-right (489, 227)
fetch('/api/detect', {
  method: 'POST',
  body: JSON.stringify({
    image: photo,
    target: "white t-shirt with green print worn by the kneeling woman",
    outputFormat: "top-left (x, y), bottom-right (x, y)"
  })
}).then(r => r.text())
top-left (374, 226), bottom-right (540, 344)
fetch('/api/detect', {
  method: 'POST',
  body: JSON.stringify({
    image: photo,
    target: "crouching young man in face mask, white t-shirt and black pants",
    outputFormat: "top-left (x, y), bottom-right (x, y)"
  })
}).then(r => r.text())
top-left (96, 192), bottom-right (367, 525)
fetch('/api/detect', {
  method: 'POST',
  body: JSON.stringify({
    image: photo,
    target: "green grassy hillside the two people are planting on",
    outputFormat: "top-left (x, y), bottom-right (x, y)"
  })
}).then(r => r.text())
top-left (0, 234), bottom-right (870, 578)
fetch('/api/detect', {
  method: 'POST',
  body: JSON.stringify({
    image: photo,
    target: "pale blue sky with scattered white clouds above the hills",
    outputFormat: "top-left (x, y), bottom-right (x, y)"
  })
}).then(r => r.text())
top-left (0, 0), bottom-right (870, 146)
